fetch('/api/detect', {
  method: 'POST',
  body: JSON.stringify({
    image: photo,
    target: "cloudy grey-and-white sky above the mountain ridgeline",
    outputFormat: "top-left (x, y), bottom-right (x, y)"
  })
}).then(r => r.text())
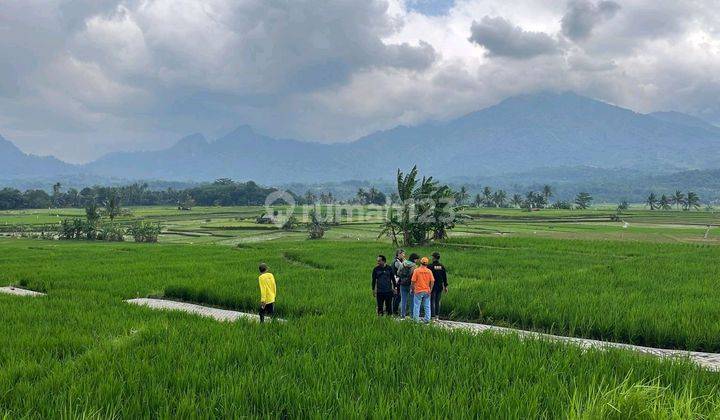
top-left (0, 0), bottom-right (720, 162)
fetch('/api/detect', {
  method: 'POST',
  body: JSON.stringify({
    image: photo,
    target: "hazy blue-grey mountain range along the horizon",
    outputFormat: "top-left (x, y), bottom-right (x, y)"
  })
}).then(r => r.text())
top-left (0, 92), bottom-right (720, 185)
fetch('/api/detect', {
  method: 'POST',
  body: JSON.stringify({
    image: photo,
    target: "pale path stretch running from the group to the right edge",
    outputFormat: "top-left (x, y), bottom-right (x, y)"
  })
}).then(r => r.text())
top-left (434, 321), bottom-right (720, 371)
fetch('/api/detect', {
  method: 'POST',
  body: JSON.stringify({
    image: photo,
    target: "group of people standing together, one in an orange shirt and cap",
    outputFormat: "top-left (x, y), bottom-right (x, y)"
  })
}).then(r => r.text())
top-left (372, 249), bottom-right (448, 323)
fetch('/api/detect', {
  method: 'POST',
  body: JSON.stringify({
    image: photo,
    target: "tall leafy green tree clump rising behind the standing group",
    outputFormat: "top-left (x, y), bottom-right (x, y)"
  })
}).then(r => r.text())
top-left (378, 166), bottom-right (461, 246)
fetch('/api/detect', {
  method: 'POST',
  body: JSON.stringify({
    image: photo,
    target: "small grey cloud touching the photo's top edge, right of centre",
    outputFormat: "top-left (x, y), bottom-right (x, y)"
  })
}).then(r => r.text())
top-left (562, 0), bottom-right (620, 41)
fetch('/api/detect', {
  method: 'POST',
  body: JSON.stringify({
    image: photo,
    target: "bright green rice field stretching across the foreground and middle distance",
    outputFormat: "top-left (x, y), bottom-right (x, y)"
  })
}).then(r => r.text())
top-left (0, 207), bottom-right (720, 420)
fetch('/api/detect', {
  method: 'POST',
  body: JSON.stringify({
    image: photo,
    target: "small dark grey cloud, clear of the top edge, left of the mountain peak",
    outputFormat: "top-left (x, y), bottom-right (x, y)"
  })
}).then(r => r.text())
top-left (469, 16), bottom-right (558, 58)
